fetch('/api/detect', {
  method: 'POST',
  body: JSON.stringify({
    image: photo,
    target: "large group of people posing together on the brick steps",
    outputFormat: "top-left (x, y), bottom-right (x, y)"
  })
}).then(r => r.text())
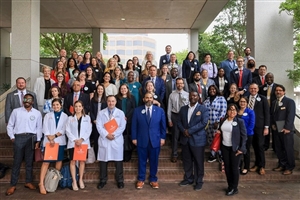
top-left (5, 45), bottom-right (295, 195)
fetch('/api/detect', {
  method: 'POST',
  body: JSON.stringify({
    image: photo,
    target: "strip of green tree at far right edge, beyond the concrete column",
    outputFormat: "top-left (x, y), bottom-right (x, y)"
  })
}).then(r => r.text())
top-left (279, 0), bottom-right (300, 86)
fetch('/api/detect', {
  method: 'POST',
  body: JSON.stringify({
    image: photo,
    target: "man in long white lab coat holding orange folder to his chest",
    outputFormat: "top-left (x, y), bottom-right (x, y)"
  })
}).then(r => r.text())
top-left (96, 95), bottom-right (126, 189)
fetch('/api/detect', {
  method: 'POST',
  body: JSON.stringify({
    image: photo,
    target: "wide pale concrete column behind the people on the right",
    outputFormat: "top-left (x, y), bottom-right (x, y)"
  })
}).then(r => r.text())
top-left (247, 0), bottom-right (294, 98)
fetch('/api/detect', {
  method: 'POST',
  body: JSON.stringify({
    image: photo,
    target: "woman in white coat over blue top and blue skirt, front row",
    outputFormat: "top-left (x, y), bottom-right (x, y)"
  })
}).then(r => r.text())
top-left (39, 98), bottom-right (68, 194)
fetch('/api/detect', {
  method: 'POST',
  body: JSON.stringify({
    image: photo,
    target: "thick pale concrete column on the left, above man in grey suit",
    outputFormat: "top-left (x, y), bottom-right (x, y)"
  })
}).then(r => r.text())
top-left (11, 0), bottom-right (40, 89)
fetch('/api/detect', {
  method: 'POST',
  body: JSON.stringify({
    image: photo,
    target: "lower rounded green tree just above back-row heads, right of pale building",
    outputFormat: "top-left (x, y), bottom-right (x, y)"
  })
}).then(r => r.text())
top-left (198, 33), bottom-right (229, 65)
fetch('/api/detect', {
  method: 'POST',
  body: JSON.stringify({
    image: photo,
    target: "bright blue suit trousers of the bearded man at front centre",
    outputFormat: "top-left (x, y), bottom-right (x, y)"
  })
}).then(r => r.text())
top-left (137, 141), bottom-right (160, 182)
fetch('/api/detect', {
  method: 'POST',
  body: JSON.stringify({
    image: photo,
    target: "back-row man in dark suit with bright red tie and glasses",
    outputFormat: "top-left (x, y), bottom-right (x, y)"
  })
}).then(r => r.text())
top-left (230, 56), bottom-right (252, 95)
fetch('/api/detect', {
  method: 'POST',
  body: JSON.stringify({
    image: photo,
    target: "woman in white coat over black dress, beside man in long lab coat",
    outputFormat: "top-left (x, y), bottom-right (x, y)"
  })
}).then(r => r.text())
top-left (66, 100), bottom-right (92, 191)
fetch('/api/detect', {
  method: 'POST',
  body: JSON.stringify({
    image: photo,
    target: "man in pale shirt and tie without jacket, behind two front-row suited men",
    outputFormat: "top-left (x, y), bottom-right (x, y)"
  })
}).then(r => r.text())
top-left (168, 78), bottom-right (189, 163)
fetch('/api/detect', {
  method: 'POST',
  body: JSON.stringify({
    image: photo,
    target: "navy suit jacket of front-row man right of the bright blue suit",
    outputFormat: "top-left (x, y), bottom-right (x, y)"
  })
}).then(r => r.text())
top-left (177, 104), bottom-right (209, 146)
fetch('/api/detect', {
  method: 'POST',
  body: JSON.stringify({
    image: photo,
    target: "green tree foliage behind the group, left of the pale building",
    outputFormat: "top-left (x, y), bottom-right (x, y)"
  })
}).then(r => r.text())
top-left (40, 33), bottom-right (108, 57)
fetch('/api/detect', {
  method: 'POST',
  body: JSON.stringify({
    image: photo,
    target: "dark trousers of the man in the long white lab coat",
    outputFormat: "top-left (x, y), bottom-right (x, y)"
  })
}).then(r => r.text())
top-left (99, 161), bottom-right (124, 183)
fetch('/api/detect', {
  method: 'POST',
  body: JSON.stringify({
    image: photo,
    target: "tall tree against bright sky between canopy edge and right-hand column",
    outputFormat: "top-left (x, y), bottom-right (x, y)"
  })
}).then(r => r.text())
top-left (212, 0), bottom-right (246, 56)
